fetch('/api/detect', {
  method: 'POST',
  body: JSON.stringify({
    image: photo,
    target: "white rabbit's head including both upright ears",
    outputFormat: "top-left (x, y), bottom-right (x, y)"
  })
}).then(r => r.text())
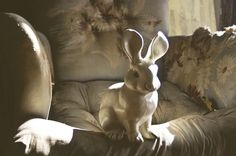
top-left (123, 29), bottom-right (169, 94)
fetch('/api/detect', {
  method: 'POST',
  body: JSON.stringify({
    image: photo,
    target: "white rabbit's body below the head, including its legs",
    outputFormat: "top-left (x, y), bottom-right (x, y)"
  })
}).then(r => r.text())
top-left (100, 83), bottom-right (158, 140)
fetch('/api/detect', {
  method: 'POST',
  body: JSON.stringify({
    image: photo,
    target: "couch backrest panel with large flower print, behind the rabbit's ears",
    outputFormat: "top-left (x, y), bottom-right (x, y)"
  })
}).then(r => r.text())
top-left (42, 0), bottom-right (168, 81)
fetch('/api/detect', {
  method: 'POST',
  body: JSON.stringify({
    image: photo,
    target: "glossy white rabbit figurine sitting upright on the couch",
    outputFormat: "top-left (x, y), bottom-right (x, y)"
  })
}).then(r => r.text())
top-left (99, 29), bottom-right (169, 142)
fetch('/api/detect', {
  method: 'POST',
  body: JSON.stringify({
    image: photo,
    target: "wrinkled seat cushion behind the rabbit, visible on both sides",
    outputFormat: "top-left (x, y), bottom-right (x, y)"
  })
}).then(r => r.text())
top-left (50, 81), bottom-right (208, 132)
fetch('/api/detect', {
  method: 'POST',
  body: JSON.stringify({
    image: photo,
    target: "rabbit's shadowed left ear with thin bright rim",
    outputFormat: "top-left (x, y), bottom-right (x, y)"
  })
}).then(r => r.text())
top-left (123, 29), bottom-right (143, 63)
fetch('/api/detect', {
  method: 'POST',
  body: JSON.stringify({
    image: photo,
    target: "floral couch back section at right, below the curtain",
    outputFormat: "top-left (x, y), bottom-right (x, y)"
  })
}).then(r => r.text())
top-left (164, 27), bottom-right (236, 108)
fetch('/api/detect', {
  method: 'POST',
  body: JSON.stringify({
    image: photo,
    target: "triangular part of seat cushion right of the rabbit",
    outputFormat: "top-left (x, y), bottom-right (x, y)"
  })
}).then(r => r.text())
top-left (153, 81), bottom-right (209, 124)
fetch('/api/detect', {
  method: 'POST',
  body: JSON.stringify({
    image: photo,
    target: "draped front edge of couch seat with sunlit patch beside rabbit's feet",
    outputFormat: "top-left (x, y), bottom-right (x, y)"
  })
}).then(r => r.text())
top-left (52, 98), bottom-right (236, 156)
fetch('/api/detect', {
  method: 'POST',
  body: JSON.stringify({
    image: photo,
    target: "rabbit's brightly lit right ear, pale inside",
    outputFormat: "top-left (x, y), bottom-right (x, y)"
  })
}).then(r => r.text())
top-left (144, 31), bottom-right (169, 63)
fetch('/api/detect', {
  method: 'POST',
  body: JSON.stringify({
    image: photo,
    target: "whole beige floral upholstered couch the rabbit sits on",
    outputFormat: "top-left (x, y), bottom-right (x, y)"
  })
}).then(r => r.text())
top-left (0, 0), bottom-right (236, 156)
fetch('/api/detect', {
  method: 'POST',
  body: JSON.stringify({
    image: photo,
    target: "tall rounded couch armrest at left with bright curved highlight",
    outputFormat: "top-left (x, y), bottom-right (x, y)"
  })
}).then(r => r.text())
top-left (0, 13), bottom-right (52, 155)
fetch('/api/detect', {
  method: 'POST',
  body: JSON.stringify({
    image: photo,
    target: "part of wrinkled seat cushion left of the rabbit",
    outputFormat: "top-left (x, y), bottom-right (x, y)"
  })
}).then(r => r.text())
top-left (50, 81), bottom-right (118, 132)
